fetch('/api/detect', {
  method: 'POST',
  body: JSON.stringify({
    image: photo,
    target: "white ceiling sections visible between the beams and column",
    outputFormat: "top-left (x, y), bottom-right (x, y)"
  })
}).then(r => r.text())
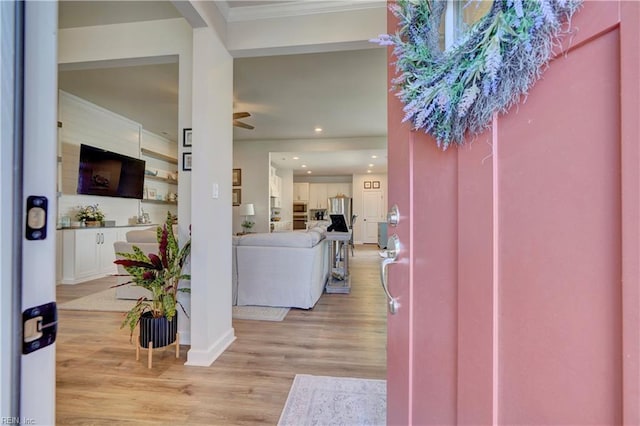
top-left (59, 1), bottom-right (387, 176)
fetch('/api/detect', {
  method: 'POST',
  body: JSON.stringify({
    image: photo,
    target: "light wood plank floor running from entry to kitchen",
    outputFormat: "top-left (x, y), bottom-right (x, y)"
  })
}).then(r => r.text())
top-left (56, 245), bottom-right (386, 425)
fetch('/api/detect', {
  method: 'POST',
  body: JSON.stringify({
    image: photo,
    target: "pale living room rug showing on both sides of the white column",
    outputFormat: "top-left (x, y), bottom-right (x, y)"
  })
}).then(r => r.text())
top-left (58, 288), bottom-right (289, 321)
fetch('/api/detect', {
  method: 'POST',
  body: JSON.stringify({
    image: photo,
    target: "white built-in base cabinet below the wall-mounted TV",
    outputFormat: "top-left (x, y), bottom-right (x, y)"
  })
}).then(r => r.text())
top-left (60, 227), bottom-right (135, 284)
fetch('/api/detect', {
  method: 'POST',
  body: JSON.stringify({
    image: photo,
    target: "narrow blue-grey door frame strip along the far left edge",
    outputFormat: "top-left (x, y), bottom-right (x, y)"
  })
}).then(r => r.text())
top-left (0, 2), bottom-right (24, 418)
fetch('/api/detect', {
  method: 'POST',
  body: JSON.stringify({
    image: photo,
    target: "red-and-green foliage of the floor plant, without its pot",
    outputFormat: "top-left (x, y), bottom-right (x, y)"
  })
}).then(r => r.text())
top-left (114, 213), bottom-right (191, 335)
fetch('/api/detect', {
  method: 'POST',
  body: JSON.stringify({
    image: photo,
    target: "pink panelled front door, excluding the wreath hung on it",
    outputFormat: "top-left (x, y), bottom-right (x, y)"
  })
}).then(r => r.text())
top-left (388, 1), bottom-right (640, 425)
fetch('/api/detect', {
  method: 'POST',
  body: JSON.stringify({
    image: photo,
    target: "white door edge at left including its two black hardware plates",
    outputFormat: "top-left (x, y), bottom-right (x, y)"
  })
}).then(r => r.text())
top-left (15, 2), bottom-right (58, 424)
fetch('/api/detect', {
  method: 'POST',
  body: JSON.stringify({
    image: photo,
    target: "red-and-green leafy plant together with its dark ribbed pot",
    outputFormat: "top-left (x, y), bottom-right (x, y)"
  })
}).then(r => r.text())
top-left (114, 212), bottom-right (191, 348)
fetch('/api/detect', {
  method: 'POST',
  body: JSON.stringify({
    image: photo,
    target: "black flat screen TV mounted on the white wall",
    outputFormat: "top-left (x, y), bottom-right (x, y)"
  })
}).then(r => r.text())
top-left (78, 144), bottom-right (145, 199)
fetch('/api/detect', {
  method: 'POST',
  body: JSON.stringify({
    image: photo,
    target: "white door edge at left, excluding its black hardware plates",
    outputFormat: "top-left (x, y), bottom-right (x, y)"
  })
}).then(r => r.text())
top-left (14, 1), bottom-right (58, 424)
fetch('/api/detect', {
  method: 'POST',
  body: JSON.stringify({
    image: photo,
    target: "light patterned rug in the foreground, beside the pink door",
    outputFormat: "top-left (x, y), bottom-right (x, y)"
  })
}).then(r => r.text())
top-left (278, 374), bottom-right (387, 426)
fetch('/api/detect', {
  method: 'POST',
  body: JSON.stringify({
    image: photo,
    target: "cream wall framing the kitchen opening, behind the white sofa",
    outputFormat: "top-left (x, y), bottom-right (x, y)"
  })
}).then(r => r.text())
top-left (233, 137), bottom-right (387, 232)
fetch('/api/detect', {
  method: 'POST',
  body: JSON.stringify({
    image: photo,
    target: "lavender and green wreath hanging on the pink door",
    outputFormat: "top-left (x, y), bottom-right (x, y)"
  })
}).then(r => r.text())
top-left (371, 0), bottom-right (582, 150)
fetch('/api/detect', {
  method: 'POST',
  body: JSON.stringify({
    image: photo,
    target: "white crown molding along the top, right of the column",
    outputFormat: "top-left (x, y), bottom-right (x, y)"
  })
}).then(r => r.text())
top-left (216, 0), bottom-right (387, 22)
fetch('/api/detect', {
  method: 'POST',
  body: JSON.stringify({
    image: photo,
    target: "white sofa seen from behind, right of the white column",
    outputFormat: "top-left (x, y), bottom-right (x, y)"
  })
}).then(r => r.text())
top-left (233, 229), bottom-right (329, 309)
